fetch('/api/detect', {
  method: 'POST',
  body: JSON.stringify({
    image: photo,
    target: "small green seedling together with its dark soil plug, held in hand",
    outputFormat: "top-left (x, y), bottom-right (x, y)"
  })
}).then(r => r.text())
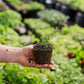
top-left (34, 29), bottom-right (57, 64)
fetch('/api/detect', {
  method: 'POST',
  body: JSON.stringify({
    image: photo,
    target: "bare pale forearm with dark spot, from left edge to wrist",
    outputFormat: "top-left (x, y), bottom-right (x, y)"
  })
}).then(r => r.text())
top-left (0, 45), bottom-right (21, 62)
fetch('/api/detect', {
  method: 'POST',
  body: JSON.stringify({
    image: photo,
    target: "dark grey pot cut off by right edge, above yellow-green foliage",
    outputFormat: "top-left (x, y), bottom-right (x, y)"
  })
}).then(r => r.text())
top-left (76, 12), bottom-right (84, 27)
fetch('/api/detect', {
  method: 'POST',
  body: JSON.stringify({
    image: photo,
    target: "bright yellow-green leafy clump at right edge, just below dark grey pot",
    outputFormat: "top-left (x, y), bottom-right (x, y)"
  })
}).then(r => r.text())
top-left (62, 25), bottom-right (84, 42)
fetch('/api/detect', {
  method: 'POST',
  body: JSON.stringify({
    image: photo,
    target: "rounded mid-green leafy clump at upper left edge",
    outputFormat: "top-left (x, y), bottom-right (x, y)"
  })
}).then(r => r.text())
top-left (0, 10), bottom-right (22, 29)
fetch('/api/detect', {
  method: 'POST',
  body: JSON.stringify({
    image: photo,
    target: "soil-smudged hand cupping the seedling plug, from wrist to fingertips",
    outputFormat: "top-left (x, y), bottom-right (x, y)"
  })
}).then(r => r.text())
top-left (18, 46), bottom-right (54, 69)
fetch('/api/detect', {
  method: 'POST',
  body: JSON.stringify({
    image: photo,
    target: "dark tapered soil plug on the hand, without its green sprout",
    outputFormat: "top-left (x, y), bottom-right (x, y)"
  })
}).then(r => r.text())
top-left (34, 43), bottom-right (53, 64)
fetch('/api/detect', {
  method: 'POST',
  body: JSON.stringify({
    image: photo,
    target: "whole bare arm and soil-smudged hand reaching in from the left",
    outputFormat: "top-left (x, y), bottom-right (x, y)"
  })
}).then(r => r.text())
top-left (0, 45), bottom-right (54, 69)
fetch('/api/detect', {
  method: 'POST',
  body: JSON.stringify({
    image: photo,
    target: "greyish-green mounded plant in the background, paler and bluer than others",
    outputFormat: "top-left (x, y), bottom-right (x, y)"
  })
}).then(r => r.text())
top-left (38, 9), bottom-right (69, 26)
